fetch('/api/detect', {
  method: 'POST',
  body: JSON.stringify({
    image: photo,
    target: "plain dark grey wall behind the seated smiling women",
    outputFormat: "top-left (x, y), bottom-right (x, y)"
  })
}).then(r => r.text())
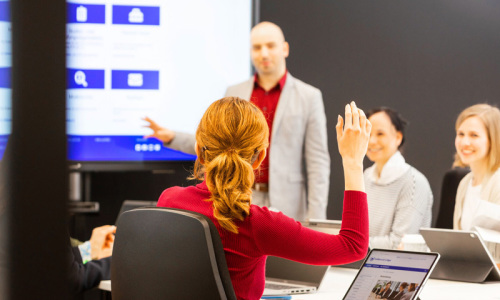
top-left (260, 0), bottom-right (500, 219)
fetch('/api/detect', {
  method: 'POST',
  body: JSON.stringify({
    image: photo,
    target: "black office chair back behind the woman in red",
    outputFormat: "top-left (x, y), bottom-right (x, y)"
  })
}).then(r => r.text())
top-left (111, 207), bottom-right (236, 300)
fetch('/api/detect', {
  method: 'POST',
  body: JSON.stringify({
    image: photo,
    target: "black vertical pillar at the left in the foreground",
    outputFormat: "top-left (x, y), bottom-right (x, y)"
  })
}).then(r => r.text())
top-left (9, 0), bottom-right (68, 299)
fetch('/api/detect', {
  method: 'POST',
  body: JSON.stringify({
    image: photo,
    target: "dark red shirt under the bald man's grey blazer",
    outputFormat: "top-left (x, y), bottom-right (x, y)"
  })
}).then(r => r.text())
top-left (250, 72), bottom-right (288, 183)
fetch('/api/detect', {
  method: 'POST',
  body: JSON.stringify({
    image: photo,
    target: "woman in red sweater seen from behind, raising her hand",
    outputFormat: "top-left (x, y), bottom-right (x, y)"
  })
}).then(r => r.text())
top-left (158, 97), bottom-right (371, 299)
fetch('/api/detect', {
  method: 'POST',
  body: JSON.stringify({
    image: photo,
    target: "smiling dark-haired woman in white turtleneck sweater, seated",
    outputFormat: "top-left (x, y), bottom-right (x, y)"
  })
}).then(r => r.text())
top-left (364, 107), bottom-right (433, 249)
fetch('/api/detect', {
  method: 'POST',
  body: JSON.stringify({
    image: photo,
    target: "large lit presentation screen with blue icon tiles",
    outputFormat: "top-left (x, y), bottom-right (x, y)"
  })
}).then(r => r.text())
top-left (67, 0), bottom-right (252, 170)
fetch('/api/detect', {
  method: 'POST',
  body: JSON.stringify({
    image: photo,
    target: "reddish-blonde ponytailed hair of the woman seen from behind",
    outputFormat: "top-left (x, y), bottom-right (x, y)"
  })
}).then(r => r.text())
top-left (193, 97), bottom-right (269, 233)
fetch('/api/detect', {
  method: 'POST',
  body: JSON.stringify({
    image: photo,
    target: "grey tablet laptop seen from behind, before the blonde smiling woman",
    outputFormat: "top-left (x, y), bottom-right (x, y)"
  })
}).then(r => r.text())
top-left (420, 228), bottom-right (500, 282)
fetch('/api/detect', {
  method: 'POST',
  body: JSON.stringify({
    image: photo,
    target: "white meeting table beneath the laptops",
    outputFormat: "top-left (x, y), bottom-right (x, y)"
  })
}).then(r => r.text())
top-left (99, 267), bottom-right (500, 300)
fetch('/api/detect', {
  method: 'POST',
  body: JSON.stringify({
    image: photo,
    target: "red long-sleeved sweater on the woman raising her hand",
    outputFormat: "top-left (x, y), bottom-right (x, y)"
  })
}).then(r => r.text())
top-left (158, 182), bottom-right (368, 299)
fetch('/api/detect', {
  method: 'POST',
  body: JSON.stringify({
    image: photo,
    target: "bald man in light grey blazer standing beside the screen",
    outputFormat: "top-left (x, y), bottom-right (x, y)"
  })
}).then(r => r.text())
top-left (145, 22), bottom-right (330, 221)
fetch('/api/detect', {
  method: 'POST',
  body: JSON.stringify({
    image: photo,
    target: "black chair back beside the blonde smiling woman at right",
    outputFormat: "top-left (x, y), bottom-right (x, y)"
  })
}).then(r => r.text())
top-left (435, 168), bottom-right (470, 229)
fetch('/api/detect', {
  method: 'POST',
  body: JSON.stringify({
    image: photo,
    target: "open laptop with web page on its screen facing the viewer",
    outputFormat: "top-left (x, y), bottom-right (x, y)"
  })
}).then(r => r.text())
top-left (343, 249), bottom-right (439, 300)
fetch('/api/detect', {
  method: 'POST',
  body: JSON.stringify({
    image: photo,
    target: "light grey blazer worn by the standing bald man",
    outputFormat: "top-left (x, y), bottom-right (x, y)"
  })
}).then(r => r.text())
top-left (166, 73), bottom-right (330, 221)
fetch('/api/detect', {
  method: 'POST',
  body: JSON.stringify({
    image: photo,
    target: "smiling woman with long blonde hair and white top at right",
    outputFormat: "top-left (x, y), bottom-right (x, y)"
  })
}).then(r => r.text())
top-left (453, 104), bottom-right (500, 230)
